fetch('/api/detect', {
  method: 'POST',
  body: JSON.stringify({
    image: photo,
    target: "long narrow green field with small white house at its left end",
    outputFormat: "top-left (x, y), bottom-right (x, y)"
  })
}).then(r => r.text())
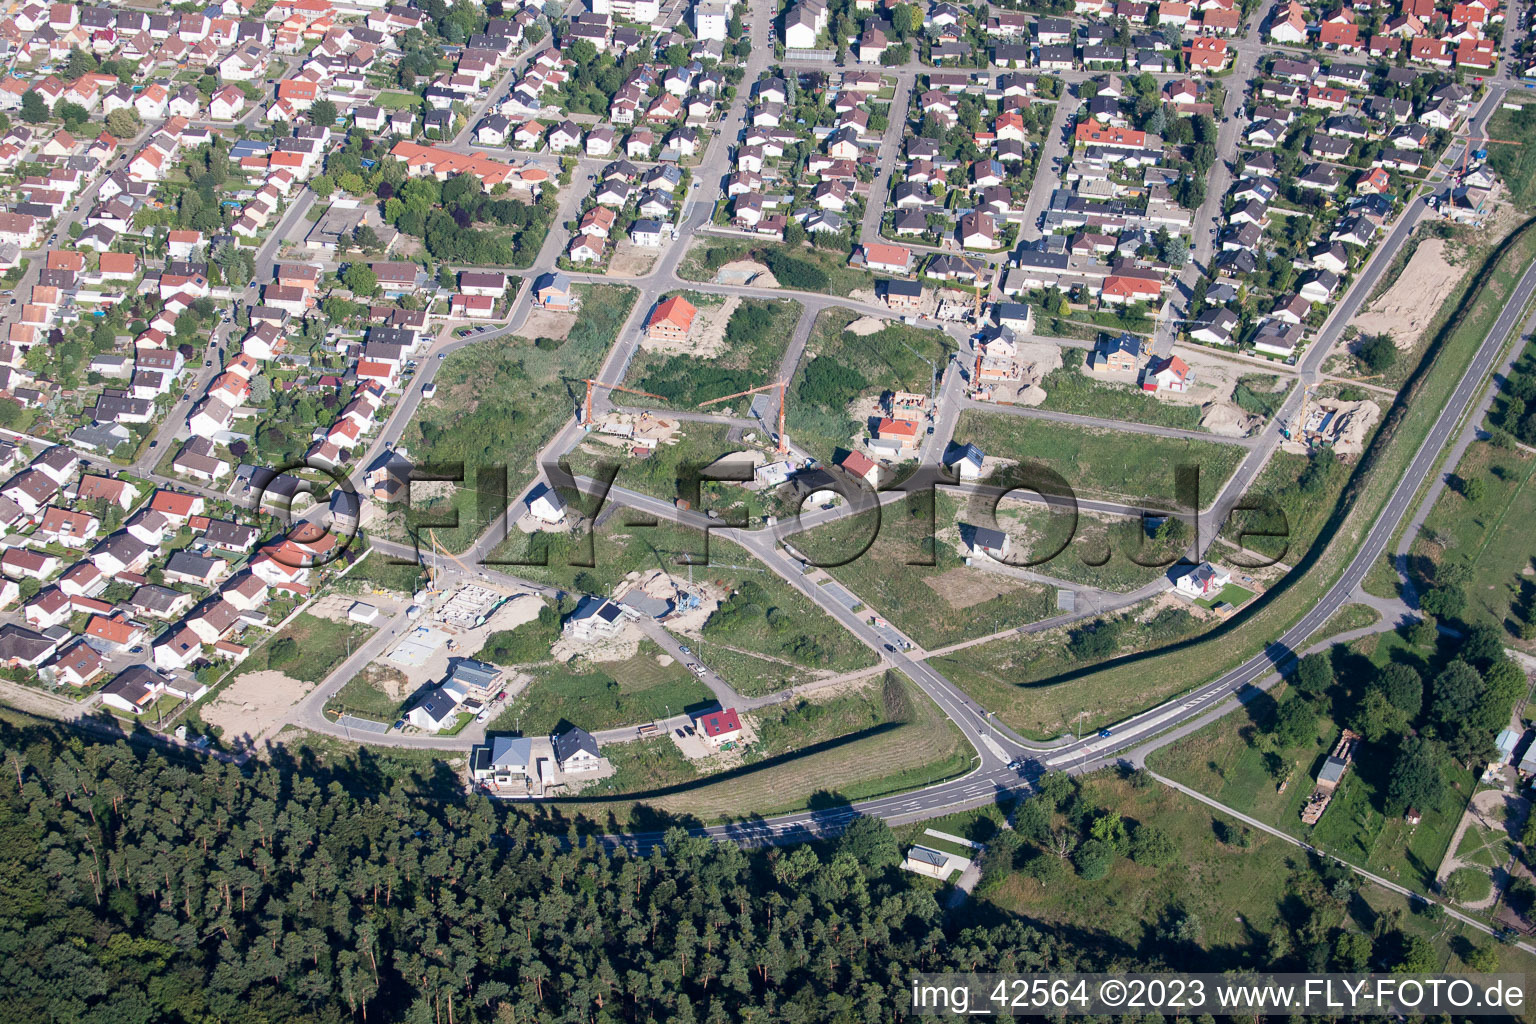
top-left (955, 410), bottom-right (1244, 508)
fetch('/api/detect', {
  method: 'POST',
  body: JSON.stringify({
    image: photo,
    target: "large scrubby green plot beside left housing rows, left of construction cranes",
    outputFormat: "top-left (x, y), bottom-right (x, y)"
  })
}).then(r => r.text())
top-left (401, 284), bottom-right (634, 551)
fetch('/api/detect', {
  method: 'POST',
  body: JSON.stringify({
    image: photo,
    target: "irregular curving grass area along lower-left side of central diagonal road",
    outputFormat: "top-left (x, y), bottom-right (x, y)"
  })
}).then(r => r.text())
top-left (493, 525), bottom-right (876, 695)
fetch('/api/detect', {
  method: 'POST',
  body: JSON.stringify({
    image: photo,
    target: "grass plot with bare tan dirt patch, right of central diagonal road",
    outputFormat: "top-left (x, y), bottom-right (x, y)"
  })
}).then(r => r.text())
top-left (793, 491), bottom-right (1055, 649)
